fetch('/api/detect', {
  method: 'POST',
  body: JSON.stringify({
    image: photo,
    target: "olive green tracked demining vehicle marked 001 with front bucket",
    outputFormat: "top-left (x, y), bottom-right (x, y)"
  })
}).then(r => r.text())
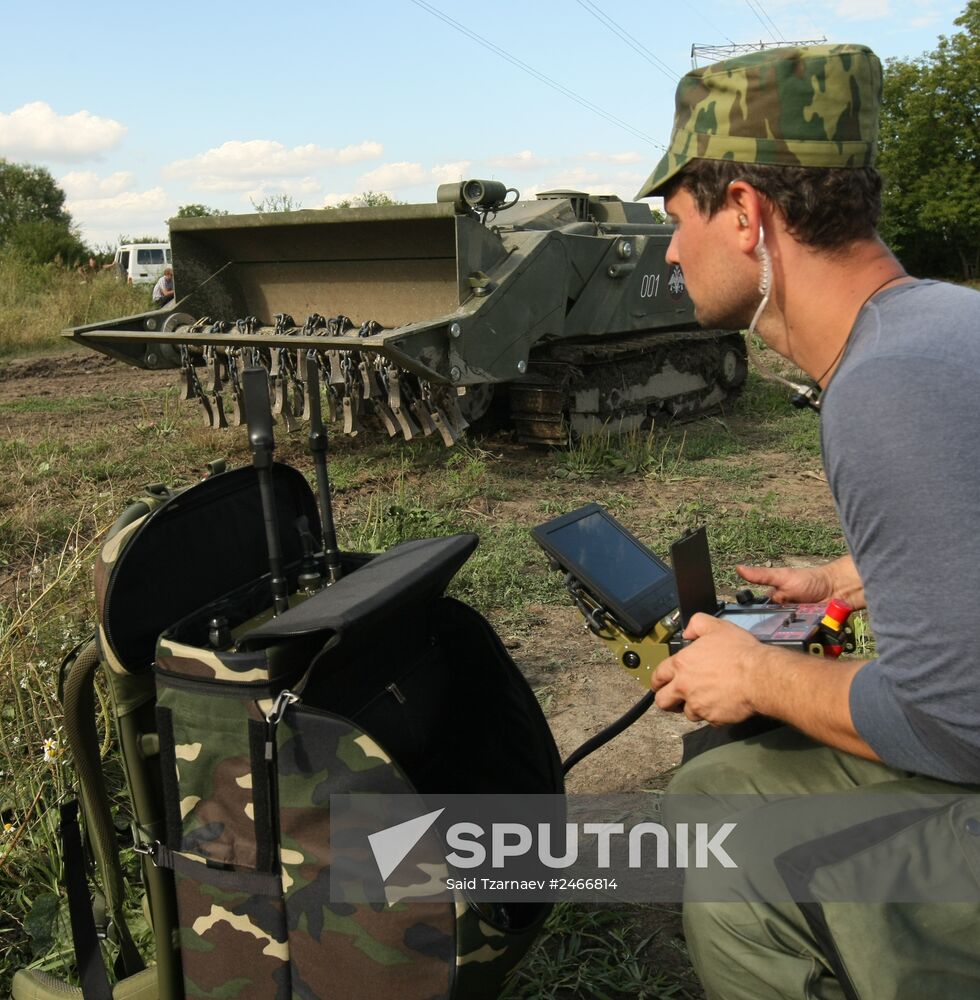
top-left (66, 180), bottom-right (746, 444)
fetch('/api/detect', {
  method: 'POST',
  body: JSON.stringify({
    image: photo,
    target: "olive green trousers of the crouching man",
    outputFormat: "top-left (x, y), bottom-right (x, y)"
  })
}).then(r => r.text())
top-left (665, 727), bottom-right (980, 1000)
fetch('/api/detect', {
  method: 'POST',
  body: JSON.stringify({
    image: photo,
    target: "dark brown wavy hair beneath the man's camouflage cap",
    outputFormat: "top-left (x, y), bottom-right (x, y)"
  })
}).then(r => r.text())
top-left (664, 159), bottom-right (881, 251)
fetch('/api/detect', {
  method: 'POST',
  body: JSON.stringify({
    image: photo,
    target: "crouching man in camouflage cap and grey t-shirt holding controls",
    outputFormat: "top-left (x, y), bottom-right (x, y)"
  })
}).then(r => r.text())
top-left (640, 45), bottom-right (980, 1000)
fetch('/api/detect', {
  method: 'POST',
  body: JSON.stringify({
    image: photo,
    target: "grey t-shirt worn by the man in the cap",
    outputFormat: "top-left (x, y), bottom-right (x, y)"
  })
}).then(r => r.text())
top-left (821, 281), bottom-right (980, 782)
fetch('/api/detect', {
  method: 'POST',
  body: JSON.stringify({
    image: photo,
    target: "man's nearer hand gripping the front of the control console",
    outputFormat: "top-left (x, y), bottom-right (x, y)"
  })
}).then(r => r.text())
top-left (650, 614), bottom-right (768, 726)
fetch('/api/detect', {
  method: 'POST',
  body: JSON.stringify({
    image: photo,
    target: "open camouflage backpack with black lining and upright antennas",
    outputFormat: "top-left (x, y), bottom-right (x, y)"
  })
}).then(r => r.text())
top-left (13, 463), bottom-right (563, 1000)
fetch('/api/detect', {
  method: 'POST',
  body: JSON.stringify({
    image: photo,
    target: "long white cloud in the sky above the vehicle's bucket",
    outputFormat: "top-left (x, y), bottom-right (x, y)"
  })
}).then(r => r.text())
top-left (163, 139), bottom-right (384, 191)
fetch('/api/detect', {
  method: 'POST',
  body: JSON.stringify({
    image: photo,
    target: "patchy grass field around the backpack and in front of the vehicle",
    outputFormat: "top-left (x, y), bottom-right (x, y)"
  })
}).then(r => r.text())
top-left (0, 342), bottom-right (842, 998)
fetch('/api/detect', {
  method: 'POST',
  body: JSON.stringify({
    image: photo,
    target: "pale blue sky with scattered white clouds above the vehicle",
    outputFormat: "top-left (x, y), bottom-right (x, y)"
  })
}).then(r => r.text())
top-left (0, 0), bottom-right (965, 247)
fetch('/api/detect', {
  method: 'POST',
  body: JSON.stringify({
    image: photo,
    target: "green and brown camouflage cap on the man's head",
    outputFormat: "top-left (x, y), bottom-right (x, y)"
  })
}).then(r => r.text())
top-left (636, 45), bottom-right (881, 198)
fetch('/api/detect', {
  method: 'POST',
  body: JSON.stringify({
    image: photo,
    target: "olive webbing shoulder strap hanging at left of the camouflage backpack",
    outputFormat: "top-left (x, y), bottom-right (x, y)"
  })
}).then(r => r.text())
top-left (62, 636), bottom-right (144, 976)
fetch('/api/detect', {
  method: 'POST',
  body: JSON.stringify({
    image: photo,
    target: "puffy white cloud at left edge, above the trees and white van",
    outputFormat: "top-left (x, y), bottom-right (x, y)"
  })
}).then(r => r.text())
top-left (0, 101), bottom-right (126, 163)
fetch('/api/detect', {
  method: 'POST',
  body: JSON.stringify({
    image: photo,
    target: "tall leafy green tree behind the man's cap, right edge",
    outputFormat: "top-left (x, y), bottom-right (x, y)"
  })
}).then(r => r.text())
top-left (878, 0), bottom-right (980, 279)
